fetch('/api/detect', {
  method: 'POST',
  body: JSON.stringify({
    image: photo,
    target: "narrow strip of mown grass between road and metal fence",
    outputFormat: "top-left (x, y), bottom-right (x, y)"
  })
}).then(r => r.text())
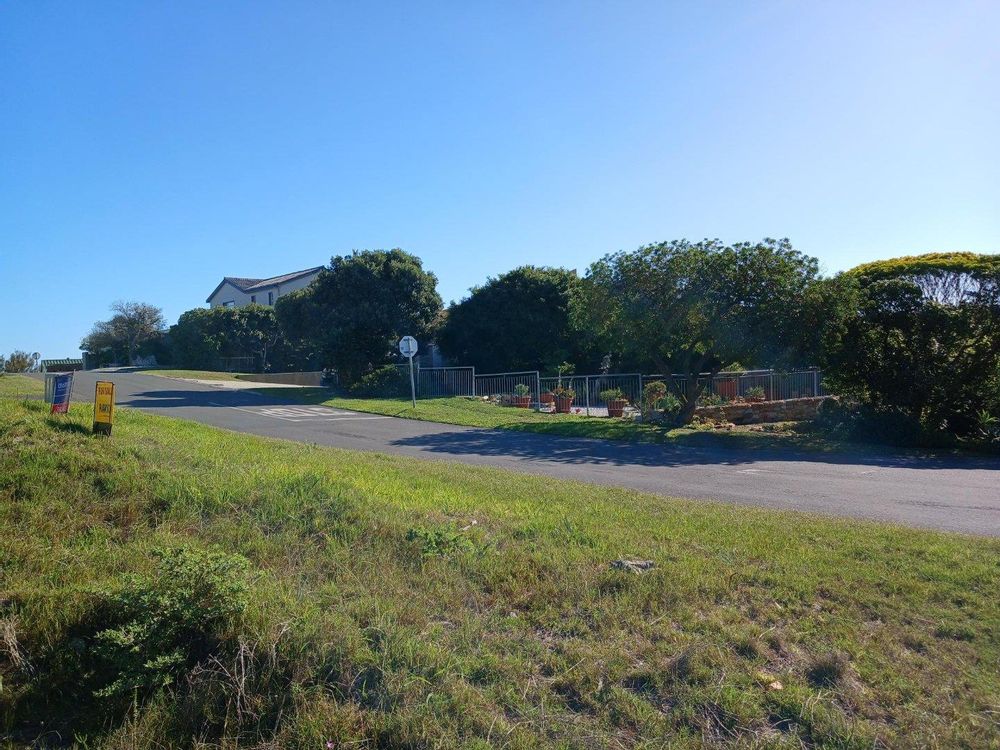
top-left (256, 388), bottom-right (843, 450)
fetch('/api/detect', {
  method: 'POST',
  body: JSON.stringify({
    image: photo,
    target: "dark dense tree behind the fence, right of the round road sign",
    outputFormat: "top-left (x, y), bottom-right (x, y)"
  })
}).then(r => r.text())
top-left (438, 266), bottom-right (586, 372)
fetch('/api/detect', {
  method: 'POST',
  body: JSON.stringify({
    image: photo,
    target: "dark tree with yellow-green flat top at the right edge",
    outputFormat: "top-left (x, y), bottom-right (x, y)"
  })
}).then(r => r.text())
top-left (824, 253), bottom-right (1000, 435)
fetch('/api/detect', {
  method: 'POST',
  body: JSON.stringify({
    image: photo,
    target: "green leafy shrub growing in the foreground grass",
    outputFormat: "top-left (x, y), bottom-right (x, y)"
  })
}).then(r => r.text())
top-left (91, 547), bottom-right (249, 700)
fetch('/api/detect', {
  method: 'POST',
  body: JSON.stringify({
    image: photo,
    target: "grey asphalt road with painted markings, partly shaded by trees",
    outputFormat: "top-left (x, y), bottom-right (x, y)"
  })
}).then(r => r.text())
top-left (48, 372), bottom-right (1000, 536)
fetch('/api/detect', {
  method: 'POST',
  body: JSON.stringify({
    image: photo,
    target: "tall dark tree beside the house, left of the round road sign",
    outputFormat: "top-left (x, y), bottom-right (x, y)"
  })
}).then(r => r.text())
top-left (275, 249), bottom-right (441, 383)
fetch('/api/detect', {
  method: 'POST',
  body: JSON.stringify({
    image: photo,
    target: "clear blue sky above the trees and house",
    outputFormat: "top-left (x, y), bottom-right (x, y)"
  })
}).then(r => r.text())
top-left (0, 0), bottom-right (1000, 357)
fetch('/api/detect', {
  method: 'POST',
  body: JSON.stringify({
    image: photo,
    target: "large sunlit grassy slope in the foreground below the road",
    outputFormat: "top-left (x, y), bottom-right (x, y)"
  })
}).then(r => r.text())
top-left (0, 400), bottom-right (1000, 748)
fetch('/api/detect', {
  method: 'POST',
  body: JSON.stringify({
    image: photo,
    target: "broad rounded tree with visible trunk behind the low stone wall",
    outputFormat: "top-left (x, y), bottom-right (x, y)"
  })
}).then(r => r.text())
top-left (574, 238), bottom-right (818, 422)
